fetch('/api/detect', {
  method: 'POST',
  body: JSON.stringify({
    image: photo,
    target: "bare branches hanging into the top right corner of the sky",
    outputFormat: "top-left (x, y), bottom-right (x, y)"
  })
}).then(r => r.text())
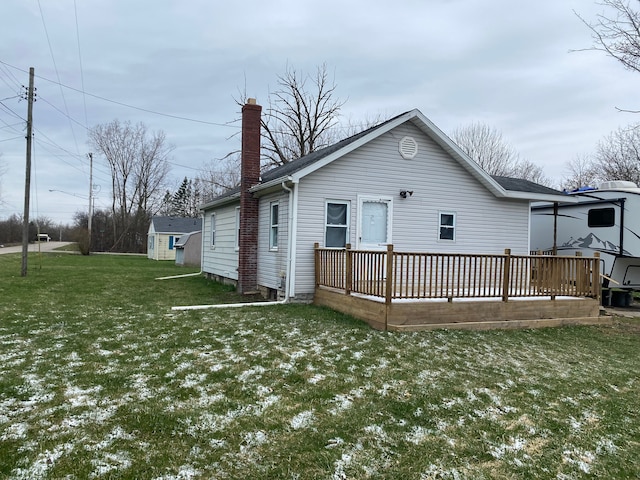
top-left (576, 0), bottom-right (640, 113)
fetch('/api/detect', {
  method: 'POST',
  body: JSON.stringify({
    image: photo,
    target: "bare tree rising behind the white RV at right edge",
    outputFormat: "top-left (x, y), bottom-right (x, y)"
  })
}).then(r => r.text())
top-left (594, 124), bottom-right (640, 185)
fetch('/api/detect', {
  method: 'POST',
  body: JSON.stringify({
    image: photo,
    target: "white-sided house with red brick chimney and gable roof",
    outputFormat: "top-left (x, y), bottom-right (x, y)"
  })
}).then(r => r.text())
top-left (201, 99), bottom-right (567, 300)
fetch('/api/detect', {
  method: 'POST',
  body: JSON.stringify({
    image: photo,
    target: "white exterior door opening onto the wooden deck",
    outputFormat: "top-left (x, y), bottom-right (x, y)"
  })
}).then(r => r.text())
top-left (358, 197), bottom-right (392, 250)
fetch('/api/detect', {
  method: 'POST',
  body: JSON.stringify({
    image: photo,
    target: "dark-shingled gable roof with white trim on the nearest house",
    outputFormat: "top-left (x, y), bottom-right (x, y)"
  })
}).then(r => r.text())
top-left (201, 109), bottom-right (568, 209)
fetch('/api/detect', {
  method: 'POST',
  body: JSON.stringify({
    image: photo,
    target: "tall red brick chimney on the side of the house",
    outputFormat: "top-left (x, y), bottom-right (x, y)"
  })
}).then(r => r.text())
top-left (238, 98), bottom-right (262, 294)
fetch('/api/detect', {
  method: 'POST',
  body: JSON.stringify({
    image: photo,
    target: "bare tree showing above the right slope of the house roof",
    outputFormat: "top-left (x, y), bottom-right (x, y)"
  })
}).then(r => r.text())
top-left (453, 122), bottom-right (551, 185)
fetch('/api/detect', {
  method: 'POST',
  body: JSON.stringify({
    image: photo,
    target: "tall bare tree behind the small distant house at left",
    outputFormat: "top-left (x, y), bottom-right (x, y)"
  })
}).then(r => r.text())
top-left (89, 120), bottom-right (172, 251)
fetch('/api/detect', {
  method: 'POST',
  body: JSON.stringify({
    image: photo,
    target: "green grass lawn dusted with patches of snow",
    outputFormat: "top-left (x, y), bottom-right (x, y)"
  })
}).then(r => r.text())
top-left (0, 253), bottom-right (640, 480)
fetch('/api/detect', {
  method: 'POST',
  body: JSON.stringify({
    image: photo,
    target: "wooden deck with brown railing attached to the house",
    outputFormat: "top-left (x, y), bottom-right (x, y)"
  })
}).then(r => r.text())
top-left (314, 246), bottom-right (610, 331)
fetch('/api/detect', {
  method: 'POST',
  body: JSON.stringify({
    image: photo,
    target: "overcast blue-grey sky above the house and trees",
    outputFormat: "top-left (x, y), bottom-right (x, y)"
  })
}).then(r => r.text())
top-left (0, 0), bottom-right (640, 223)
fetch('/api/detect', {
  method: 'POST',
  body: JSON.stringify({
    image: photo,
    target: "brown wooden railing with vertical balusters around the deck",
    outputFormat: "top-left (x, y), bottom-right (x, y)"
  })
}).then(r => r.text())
top-left (315, 244), bottom-right (600, 303)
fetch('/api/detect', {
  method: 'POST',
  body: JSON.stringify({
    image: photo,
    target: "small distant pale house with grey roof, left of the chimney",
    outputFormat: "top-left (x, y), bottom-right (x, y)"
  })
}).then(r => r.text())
top-left (147, 217), bottom-right (202, 260)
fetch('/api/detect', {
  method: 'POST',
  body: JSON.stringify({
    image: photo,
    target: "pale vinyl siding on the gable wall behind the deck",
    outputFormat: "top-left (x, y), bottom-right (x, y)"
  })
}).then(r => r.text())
top-left (295, 124), bottom-right (529, 294)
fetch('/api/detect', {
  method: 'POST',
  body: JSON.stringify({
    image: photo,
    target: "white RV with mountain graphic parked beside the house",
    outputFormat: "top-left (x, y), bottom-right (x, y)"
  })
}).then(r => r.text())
top-left (531, 181), bottom-right (640, 290)
